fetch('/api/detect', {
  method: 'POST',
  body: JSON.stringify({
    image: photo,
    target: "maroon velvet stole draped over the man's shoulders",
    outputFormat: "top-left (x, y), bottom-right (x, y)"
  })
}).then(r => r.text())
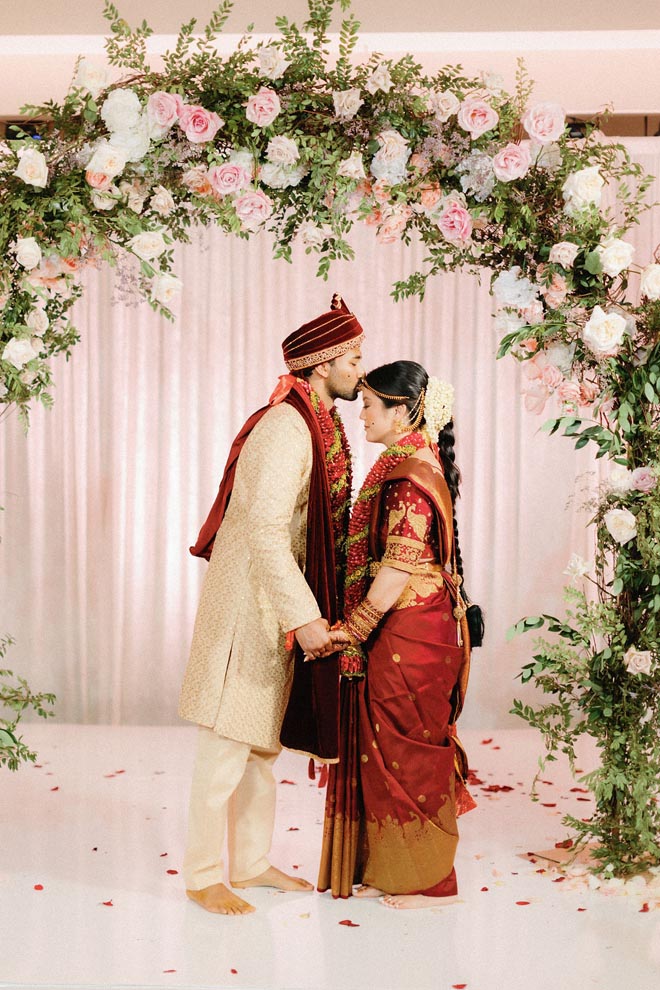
top-left (190, 383), bottom-right (339, 762)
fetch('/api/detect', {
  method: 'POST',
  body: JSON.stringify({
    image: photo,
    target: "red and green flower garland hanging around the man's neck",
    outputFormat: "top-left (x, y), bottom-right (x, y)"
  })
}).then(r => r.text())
top-left (303, 382), bottom-right (353, 603)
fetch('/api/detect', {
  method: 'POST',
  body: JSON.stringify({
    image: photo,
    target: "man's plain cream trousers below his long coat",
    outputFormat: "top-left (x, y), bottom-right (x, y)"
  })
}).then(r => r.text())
top-left (183, 726), bottom-right (280, 890)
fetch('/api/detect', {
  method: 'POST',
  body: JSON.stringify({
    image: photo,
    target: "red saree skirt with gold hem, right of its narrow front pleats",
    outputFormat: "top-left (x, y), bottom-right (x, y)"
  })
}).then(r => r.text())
top-left (359, 589), bottom-right (464, 897)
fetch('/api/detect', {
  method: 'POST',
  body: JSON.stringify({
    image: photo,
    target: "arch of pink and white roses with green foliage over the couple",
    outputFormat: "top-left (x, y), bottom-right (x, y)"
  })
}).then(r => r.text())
top-left (0, 0), bottom-right (660, 874)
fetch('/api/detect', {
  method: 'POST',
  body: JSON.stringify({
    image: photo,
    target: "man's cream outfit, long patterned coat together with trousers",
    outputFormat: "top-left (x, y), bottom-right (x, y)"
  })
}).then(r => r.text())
top-left (179, 403), bottom-right (320, 889)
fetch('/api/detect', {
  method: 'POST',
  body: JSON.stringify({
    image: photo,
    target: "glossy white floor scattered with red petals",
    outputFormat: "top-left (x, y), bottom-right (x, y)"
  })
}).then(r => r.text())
top-left (0, 724), bottom-right (660, 990)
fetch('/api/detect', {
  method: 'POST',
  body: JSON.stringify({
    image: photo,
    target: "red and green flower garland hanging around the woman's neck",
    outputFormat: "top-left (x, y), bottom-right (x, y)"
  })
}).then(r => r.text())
top-left (340, 432), bottom-right (426, 676)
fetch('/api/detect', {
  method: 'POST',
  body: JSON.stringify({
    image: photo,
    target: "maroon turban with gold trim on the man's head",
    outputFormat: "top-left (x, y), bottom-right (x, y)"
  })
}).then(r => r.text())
top-left (282, 292), bottom-right (364, 371)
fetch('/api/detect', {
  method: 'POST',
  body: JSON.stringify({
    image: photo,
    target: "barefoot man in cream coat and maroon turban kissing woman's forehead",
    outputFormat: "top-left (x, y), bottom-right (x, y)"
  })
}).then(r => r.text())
top-left (179, 295), bottom-right (363, 914)
